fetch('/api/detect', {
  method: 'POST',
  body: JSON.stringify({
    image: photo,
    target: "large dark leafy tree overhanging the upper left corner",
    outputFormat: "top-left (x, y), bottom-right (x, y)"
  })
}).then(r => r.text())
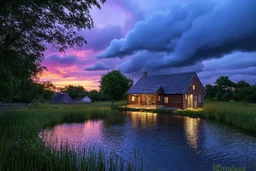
top-left (0, 0), bottom-right (105, 101)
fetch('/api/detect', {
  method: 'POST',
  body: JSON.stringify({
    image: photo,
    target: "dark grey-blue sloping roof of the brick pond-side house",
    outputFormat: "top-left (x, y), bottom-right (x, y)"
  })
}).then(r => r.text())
top-left (126, 72), bottom-right (196, 94)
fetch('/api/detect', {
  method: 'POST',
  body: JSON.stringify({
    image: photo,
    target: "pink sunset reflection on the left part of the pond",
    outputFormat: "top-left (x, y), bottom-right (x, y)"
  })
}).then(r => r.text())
top-left (39, 121), bottom-right (103, 150)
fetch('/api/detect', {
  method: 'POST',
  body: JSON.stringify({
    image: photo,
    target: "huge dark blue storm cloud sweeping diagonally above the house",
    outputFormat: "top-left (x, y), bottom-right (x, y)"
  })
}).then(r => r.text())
top-left (97, 0), bottom-right (256, 68)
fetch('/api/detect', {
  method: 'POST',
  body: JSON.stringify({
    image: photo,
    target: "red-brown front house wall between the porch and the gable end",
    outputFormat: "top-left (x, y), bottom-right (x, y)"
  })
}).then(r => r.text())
top-left (162, 94), bottom-right (183, 109)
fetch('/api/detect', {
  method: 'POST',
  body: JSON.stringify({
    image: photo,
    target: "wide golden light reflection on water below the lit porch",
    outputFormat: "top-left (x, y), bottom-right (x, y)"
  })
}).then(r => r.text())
top-left (127, 112), bottom-right (157, 128)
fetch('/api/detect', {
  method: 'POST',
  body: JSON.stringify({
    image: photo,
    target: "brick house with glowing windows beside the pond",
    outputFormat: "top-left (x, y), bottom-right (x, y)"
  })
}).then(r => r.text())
top-left (126, 72), bottom-right (205, 109)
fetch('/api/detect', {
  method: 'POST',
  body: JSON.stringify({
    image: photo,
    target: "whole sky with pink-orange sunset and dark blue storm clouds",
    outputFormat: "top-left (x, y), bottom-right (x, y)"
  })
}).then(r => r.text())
top-left (40, 0), bottom-right (256, 90)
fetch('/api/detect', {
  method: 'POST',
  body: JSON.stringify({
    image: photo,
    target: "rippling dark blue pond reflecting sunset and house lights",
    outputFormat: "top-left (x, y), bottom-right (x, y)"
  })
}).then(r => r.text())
top-left (40, 112), bottom-right (256, 170)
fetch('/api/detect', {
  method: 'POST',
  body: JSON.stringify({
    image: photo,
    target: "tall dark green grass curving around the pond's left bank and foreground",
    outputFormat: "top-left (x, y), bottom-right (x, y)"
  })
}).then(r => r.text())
top-left (0, 104), bottom-right (140, 171)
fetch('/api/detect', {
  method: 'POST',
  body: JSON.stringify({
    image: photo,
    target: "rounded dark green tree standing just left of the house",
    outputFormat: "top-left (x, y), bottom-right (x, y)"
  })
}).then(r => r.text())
top-left (100, 70), bottom-right (133, 105)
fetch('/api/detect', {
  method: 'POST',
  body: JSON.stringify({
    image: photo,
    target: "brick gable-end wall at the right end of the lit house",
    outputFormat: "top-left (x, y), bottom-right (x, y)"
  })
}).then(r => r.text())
top-left (183, 76), bottom-right (205, 109)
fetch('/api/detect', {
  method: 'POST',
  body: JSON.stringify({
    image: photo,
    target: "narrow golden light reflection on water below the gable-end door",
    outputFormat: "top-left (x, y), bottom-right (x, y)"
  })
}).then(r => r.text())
top-left (184, 117), bottom-right (200, 150)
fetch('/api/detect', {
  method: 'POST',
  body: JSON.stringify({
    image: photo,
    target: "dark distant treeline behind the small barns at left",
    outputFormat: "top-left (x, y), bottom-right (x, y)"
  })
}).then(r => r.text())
top-left (0, 80), bottom-right (108, 103)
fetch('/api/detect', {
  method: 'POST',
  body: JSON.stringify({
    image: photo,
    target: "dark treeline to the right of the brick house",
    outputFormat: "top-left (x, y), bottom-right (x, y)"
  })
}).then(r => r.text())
top-left (205, 76), bottom-right (256, 103)
